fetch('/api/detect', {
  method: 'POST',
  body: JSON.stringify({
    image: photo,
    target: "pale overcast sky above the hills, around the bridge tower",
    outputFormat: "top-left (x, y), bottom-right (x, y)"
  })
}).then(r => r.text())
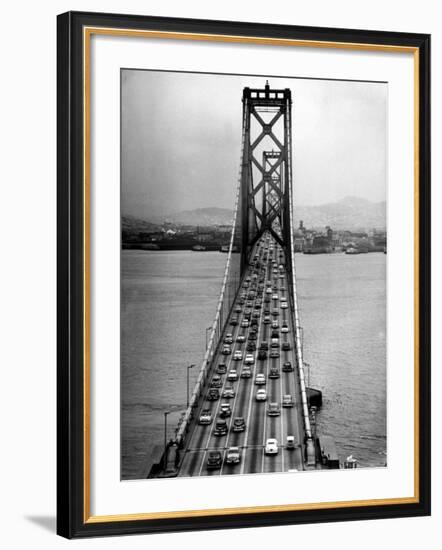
top-left (121, 70), bottom-right (388, 218)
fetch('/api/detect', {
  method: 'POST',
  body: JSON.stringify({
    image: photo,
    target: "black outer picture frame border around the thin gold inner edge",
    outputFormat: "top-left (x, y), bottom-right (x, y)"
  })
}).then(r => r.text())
top-left (57, 12), bottom-right (431, 538)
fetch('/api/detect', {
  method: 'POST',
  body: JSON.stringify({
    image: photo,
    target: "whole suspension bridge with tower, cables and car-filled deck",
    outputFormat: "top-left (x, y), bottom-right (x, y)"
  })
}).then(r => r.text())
top-left (148, 82), bottom-right (339, 477)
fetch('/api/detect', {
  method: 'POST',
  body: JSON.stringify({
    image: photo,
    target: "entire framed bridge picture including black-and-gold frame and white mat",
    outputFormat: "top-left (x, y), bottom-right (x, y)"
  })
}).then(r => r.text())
top-left (57, 12), bottom-right (430, 538)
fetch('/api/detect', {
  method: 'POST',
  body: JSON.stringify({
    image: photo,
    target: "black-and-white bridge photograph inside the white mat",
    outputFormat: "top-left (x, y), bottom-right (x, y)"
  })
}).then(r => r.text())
top-left (120, 68), bottom-right (388, 480)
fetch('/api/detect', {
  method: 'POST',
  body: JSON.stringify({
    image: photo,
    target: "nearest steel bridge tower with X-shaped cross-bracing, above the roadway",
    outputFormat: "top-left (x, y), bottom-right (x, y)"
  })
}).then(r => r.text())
top-left (241, 82), bottom-right (292, 270)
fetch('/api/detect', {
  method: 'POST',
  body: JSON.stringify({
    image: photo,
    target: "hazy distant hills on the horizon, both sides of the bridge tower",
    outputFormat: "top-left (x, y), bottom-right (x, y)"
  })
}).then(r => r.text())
top-left (123, 197), bottom-right (386, 232)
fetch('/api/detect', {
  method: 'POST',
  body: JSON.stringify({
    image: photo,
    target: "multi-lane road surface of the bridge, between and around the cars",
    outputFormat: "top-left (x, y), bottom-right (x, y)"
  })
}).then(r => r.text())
top-left (178, 234), bottom-right (304, 476)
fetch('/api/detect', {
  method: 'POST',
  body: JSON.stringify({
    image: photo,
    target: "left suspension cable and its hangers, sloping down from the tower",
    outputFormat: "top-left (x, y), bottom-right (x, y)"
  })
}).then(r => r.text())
top-left (175, 109), bottom-right (245, 446)
